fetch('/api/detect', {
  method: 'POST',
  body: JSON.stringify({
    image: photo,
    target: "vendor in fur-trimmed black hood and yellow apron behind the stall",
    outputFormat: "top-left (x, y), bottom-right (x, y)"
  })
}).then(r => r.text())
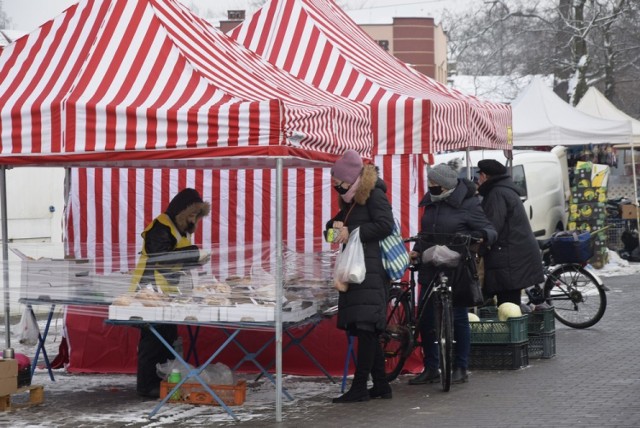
top-left (130, 188), bottom-right (211, 398)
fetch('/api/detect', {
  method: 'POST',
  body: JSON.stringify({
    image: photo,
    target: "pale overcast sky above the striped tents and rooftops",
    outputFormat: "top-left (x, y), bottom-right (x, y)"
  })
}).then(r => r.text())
top-left (3, 0), bottom-right (474, 32)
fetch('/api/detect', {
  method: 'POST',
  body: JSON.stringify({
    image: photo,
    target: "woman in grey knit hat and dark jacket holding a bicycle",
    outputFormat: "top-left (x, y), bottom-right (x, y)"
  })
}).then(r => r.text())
top-left (409, 159), bottom-right (497, 385)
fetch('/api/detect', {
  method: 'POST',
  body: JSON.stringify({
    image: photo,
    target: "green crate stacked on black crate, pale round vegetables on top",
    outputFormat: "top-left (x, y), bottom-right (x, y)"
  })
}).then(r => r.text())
top-left (469, 307), bottom-right (529, 370)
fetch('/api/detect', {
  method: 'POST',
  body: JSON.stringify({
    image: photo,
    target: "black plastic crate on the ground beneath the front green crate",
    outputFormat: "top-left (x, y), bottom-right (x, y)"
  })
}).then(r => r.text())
top-left (469, 342), bottom-right (529, 370)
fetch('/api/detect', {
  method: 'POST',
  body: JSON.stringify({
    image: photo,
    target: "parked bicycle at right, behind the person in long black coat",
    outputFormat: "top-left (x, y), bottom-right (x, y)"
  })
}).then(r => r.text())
top-left (525, 240), bottom-right (607, 329)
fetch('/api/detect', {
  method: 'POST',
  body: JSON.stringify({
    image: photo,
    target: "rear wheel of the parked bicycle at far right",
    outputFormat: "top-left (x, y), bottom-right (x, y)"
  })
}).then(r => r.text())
top-left (544, 264), bottom-right (607, 328)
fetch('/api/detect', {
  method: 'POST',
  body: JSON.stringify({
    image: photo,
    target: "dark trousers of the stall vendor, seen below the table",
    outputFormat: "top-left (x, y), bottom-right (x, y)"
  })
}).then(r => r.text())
top-left (136, 324), bottom-right (178, 393)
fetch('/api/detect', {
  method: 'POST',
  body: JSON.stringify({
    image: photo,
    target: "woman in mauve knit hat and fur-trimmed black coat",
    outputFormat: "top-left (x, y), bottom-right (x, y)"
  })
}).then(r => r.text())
top-left (326, 150), bottom-right (394, 403)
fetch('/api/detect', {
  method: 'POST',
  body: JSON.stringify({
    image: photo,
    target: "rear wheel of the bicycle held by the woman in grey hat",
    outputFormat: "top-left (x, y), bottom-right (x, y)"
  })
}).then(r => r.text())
top-left (380, 288), bottom-right (413, 381)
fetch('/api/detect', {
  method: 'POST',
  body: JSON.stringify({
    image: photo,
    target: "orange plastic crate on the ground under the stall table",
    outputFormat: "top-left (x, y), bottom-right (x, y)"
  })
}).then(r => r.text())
top-left (160, 380), bottom-right (247, 406)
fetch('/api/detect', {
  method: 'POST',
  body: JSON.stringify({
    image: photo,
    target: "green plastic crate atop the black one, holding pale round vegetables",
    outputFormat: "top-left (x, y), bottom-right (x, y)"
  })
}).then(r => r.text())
top-left (469, 314), bottom-right (529, 344)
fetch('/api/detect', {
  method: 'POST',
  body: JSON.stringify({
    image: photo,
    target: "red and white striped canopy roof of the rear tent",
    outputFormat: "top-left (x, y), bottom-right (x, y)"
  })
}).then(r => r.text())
top-left (230, 0), bottom-right (511, 155)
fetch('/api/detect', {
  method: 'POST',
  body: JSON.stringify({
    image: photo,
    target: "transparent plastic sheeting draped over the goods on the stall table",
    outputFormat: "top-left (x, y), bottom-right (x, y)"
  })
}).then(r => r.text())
top-left (9, 239), bottom-right (338, 322)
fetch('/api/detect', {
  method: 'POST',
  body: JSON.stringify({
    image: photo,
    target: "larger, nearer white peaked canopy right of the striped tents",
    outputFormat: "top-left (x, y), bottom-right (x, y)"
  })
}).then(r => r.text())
top-left (512, 77), bottom-right (631, 146)
